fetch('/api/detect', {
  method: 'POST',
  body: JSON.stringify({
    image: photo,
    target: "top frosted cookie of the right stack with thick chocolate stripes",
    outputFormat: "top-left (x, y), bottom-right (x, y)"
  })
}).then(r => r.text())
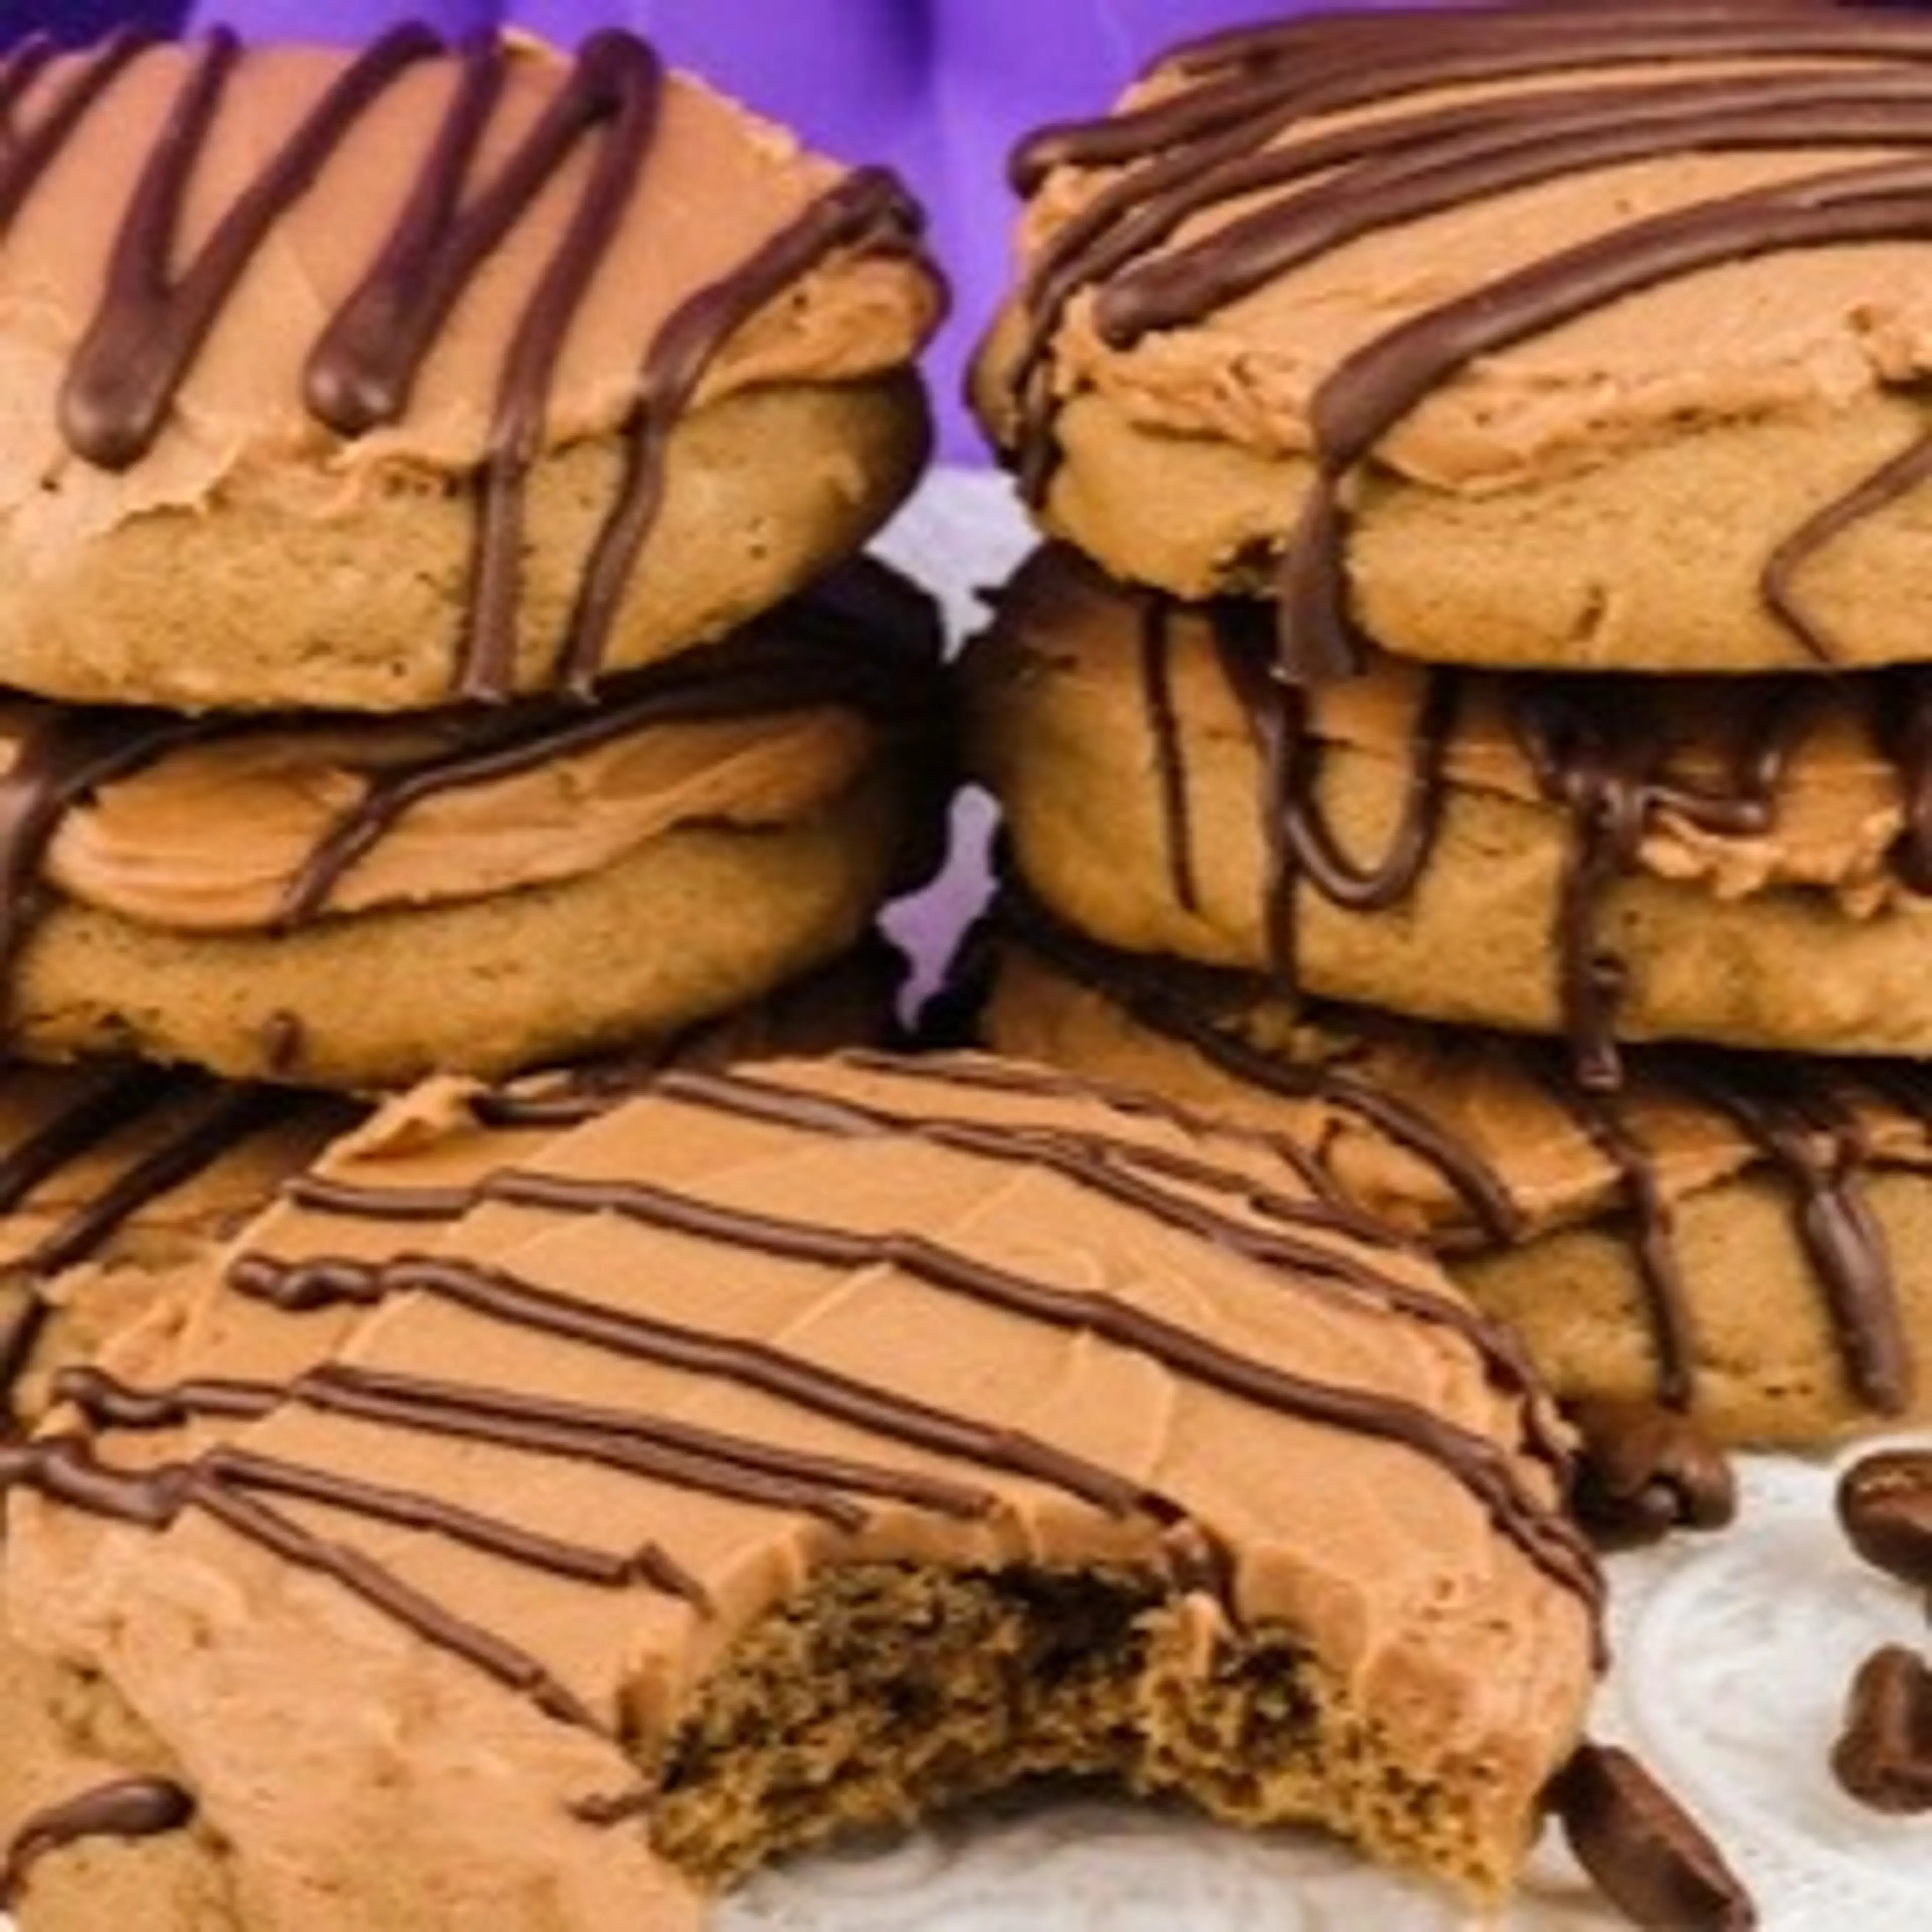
top-left (976, 0), bottom-right (1932, 678)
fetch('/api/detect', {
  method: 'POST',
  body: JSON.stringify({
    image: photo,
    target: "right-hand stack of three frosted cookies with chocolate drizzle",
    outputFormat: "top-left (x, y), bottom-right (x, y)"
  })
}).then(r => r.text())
top-left (968, 0), bottom-right (1932, 1453)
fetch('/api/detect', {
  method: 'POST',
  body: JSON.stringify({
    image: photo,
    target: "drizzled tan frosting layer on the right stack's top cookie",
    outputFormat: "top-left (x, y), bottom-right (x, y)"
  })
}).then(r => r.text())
top-left (987, 0), bottom-right (1932, 674)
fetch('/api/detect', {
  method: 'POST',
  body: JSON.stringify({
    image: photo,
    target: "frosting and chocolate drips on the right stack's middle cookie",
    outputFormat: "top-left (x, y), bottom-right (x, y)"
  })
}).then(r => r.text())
top-left (978, 547), bottom-right (1932, 1086)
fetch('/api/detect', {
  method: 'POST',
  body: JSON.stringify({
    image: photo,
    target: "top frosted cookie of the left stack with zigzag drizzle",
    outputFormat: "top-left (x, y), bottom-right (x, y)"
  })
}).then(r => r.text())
top-left (0, 25), bottom-right (943, 711)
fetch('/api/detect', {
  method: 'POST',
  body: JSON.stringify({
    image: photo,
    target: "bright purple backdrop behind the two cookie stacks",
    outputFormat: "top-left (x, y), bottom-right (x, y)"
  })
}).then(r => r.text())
top-left (0, 0), bottom-right (1308, 460)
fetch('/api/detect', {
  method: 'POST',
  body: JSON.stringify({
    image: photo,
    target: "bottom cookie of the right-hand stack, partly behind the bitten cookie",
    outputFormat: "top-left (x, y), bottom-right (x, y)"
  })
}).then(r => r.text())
top-left (982, 900), bottom-right (1932, 1447)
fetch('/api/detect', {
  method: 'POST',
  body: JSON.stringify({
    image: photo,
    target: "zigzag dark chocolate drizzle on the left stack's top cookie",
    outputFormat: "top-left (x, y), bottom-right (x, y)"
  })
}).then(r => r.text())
top-left (0, 23), bottom-right (920, 699)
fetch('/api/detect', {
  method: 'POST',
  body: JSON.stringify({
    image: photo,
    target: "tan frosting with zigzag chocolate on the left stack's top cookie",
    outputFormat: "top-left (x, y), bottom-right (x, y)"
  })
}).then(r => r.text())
top-left (0, 27), bottom-right (941, 692)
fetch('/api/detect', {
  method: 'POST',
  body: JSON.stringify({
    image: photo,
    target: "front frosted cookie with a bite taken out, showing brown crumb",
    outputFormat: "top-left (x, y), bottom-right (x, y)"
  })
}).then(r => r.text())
top-left (0, 1057), bottom-right (1600, 1932)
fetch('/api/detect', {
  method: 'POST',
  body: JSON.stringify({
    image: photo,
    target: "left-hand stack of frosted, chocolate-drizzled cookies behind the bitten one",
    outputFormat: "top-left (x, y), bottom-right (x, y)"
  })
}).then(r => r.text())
top-left (0, 27), bottom-right (943, 1429)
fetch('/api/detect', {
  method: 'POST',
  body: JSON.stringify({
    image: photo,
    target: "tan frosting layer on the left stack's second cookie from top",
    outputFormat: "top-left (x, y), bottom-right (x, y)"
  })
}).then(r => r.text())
top-left (0, 562), bottom-right (939, 946)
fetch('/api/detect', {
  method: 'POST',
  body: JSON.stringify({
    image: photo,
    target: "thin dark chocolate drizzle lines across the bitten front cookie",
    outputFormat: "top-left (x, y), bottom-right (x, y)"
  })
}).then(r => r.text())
top-left (0, 1063), bottom-right (1601, 1754)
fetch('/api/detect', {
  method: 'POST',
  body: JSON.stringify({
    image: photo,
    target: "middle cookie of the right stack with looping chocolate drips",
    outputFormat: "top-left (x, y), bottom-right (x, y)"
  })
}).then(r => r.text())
top-left (966, 547), bottom-right (1932, 1086)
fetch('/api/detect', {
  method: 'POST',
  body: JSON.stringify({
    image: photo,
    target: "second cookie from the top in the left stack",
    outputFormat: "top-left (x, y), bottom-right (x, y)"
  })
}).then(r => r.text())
top-left (0, 564), bottom-right (945, 1086)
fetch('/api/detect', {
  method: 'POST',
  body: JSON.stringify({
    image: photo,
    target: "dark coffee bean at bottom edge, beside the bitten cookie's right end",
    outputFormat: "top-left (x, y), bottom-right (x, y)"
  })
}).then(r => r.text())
top-left (1550, 1743), bottom-right (1758, 1932)
